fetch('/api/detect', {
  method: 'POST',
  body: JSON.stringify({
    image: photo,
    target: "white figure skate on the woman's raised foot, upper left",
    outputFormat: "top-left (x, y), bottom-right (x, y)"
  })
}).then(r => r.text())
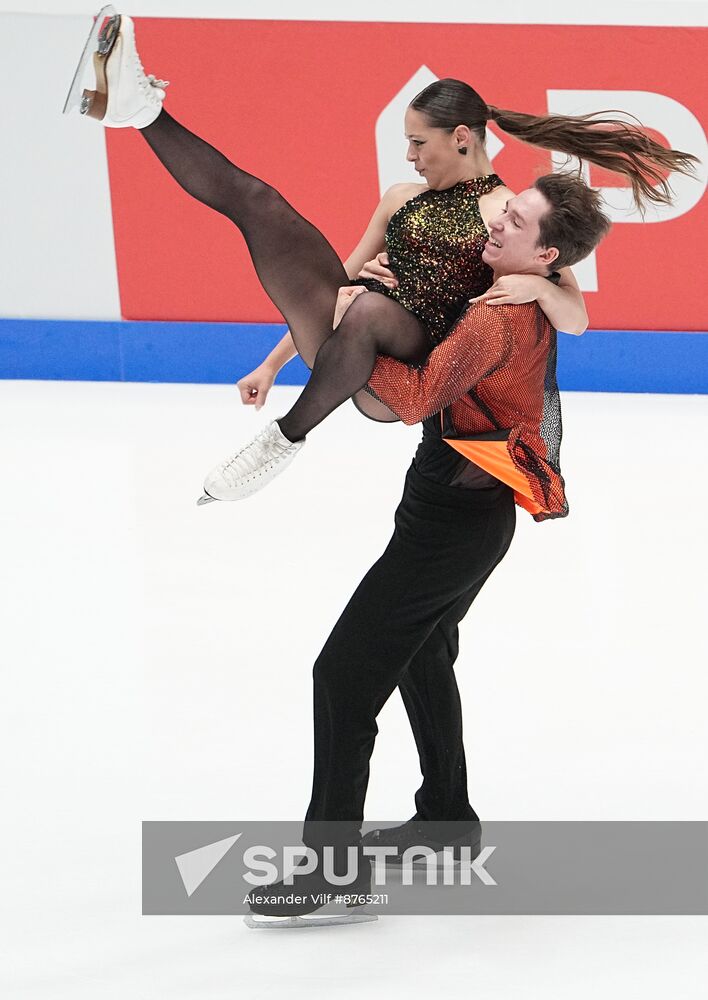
top-left (63, 6), bottom-right (169, 128)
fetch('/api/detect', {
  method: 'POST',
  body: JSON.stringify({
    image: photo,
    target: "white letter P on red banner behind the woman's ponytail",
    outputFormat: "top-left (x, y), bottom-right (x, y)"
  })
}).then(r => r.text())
top-left (547, 90), bottom-right (708, 292)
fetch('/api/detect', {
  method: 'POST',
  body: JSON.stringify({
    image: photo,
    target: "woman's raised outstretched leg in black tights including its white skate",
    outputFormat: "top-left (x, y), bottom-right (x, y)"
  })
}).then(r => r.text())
top-left (64, 8), bottom-right (348, 366)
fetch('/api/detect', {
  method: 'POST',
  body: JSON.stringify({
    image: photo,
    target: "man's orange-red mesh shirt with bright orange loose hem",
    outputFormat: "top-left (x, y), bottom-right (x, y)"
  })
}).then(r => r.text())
top-left (368, 302), bottom-right (568, 521)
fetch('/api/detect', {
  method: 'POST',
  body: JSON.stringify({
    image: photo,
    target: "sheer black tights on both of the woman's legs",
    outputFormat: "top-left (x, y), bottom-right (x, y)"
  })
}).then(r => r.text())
top-left (137, 109), bottom-right (432, 441)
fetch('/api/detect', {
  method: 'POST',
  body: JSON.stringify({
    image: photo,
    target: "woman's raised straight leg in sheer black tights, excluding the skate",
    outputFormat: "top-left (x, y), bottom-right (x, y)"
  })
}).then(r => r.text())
top-left (141, 108), bottom-right (349, 368)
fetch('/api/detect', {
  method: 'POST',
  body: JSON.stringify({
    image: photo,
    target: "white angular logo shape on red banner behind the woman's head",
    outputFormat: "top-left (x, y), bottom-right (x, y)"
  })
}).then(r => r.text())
top-left (376, 66), bottom-right (504, 194)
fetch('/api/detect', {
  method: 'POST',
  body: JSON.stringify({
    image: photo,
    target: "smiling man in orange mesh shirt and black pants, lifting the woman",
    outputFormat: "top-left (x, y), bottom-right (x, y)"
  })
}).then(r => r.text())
top-left (246, 174), bottom-right (610, 922)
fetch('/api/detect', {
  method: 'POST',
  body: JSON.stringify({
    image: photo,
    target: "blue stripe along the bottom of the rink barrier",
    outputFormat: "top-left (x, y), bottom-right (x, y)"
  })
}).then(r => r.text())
top-left (0, 319), bottom-right (708, 393)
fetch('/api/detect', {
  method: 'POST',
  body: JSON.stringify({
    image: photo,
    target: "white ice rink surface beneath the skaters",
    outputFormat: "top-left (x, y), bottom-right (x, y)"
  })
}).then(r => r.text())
top-left (0, 381), bottom-right (708, 1000)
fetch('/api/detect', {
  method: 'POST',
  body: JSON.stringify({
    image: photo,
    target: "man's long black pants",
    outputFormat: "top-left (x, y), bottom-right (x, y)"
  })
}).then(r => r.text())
top-left (303, 465), bottom-right (516, 847)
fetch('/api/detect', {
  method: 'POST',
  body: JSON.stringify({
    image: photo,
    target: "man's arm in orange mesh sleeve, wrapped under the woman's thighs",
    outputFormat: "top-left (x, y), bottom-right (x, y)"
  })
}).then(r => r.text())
top-left (368, 302), bottom-right (516, 424)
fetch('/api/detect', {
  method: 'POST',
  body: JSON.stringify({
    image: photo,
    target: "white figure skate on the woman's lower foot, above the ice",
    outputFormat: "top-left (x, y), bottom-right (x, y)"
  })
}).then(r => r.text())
top-left (197, 420), bottom-right (306, 506)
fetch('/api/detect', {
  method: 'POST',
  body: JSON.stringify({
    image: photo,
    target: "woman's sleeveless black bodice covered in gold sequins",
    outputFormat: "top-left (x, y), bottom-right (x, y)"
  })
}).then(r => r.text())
top-left (356, 174), bottom-right (504, 343)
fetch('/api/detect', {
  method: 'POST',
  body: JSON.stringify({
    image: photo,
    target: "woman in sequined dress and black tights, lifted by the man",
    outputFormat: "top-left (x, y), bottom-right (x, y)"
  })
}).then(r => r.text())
top-left (67, 14), bottom-right (643, 499)
